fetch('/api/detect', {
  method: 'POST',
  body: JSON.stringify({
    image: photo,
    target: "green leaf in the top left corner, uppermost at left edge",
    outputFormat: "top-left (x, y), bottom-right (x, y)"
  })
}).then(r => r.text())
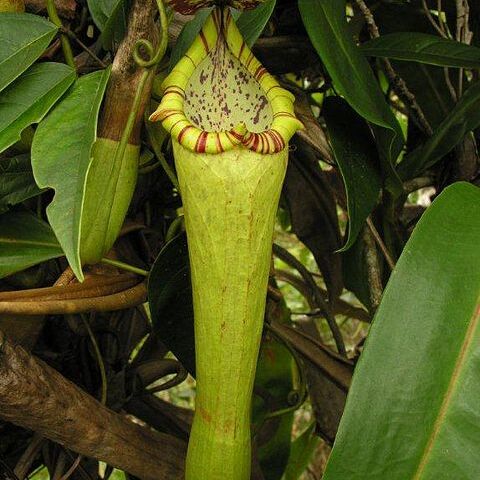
top-left (0, 13), bottom-right (57, 90)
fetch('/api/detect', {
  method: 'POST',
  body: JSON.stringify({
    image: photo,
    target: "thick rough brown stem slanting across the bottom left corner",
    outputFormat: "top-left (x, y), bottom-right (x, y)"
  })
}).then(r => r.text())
top-left (0, 332), bottom-right (186, 480)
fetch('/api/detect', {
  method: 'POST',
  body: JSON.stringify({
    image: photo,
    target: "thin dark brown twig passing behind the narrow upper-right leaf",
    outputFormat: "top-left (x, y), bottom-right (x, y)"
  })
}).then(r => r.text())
top-left (355, 0), bottom-right (433, 136)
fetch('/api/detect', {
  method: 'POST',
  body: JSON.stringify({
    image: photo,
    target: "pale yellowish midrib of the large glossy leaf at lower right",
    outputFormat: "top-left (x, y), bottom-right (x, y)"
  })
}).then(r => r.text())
top-left (412, 296), bottom-right (480, 480)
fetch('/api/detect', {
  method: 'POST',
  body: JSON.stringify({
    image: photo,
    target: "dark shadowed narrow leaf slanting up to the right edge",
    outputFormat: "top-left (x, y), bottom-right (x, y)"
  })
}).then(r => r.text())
top-left (398, 82), bottom-right (480, 179)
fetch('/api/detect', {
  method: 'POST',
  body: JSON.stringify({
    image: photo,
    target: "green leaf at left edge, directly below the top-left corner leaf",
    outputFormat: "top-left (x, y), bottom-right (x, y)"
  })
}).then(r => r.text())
top-left (0, 63), bottom-right (75, 152)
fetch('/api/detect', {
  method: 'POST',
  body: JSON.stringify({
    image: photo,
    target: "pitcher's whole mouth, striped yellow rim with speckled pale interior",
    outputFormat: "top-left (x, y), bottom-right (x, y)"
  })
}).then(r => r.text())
top-left (150, 8), bottom-right (303, 154)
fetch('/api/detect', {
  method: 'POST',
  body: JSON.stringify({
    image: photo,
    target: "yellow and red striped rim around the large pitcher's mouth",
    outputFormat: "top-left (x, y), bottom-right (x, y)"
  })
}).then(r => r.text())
top-left (150, 8), bottom-right (303, 154)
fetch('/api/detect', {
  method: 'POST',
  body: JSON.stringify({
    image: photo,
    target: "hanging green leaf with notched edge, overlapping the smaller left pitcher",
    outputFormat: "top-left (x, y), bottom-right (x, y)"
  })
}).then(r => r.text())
top-left (32, 69), bottom-right (110, 280)
